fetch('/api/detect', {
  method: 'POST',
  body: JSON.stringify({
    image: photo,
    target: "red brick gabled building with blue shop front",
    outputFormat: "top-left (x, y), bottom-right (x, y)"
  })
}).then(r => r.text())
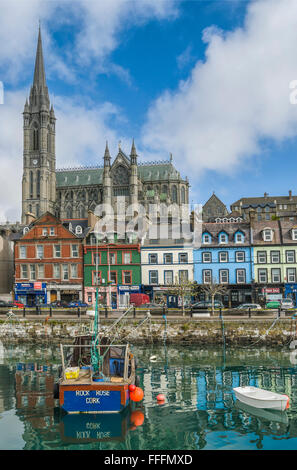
top-left (14, 212), bottom-right (83, 306)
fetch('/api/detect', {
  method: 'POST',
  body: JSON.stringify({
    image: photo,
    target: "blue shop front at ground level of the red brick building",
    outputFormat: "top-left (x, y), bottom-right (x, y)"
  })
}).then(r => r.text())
top-left (14, 282), bottom-right (47, 307)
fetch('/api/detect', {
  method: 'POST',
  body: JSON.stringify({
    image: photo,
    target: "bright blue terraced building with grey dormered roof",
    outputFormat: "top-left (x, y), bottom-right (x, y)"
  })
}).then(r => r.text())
top-left (193, 222), bottom-right (254, 307)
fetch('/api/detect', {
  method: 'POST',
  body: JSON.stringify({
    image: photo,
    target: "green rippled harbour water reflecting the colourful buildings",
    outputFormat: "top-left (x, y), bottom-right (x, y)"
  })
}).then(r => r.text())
top-left (0, 346), bottom-right (297, 450)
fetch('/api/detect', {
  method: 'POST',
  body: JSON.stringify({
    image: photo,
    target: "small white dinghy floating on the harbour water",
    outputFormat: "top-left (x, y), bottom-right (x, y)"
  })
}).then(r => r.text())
top-left (233, 386), bottom-right (290, 411)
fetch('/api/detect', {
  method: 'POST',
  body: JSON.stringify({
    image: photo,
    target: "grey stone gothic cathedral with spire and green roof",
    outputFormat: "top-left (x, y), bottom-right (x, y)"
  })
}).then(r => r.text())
top-left (22, 29), bottom-right (189, 223)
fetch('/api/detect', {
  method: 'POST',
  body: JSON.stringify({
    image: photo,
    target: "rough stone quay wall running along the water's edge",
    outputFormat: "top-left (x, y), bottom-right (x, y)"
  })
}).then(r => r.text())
top-left (0, 318), bottom-right (297, 347)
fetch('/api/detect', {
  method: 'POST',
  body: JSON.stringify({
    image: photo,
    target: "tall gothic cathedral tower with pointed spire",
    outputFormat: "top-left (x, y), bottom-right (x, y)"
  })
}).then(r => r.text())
top-left (22, 28), bottom-right (56, 223)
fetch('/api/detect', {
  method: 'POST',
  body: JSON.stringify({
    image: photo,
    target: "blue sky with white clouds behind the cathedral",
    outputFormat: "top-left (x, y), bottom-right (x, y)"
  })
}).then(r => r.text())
top-left (0, 0), bottom-right (297, 222)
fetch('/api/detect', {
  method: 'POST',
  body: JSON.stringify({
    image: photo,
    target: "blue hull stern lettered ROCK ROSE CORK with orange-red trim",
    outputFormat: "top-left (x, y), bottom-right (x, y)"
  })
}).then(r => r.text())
top-left (59, 384), bottom-right (130, 413)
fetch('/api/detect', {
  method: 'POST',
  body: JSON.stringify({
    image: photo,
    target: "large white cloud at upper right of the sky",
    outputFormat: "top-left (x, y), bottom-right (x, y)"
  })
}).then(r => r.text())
top-left (142, 0), bottom-right (297, 183)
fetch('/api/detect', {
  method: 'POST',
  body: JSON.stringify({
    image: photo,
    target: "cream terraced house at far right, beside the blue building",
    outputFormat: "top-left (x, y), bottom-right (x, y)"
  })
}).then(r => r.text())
top-left (252, 221), bottom-right (297, 302)
